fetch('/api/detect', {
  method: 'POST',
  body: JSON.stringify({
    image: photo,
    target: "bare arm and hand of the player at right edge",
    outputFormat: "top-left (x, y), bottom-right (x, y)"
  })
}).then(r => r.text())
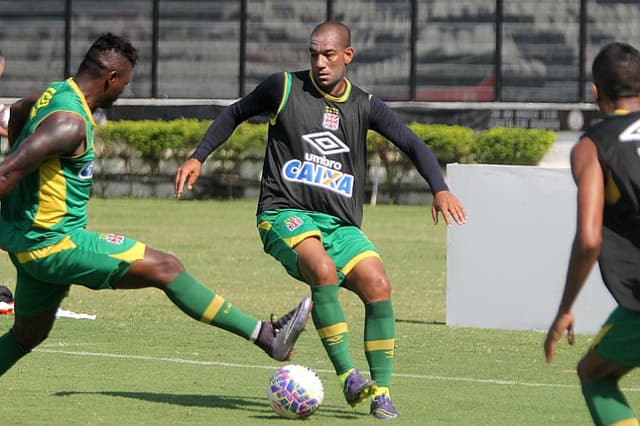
top-left (544, 138), bottom-right (604, 362)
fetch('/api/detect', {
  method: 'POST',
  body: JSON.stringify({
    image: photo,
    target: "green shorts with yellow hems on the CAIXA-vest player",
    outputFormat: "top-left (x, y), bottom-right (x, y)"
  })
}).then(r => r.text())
top-left (257, 209), bottom-right (380, 284)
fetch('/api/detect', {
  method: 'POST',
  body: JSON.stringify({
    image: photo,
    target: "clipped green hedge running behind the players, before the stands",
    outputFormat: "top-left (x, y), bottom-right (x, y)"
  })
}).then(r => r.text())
top-left (96, 119), bottom-right (555, 171)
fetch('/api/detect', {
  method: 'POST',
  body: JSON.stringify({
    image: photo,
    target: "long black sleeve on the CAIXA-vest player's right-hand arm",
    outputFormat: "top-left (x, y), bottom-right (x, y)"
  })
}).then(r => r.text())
top-left (369, 96), bottom-right (449, 194)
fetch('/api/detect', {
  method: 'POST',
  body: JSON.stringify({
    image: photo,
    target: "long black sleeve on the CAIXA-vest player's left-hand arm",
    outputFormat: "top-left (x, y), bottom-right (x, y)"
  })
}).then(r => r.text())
top-left (191, 73), bottom-right (284, 162)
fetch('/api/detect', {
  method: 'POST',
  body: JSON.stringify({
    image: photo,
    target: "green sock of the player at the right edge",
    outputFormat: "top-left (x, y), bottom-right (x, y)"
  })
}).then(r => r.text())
top-left (582, 378), bottom-right (638, 426)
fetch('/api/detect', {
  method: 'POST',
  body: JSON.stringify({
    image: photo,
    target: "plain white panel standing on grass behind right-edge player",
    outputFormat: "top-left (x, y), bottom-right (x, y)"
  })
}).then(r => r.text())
top-left (447, 164), bottom-right (615, 333)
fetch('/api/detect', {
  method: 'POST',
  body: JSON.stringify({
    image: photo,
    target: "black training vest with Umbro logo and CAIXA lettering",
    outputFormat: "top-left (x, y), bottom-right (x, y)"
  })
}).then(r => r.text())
top-left (258, 70), bottom-right (370, 226)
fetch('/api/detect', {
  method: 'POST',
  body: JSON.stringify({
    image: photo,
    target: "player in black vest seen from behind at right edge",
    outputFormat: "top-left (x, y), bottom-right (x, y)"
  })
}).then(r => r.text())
top-left (544, 43), bottom-right (640, 426)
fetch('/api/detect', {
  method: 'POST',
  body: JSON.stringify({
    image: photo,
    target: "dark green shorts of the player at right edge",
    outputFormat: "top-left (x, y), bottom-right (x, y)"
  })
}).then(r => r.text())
top-left (591, 306), bottom-right (640, 368)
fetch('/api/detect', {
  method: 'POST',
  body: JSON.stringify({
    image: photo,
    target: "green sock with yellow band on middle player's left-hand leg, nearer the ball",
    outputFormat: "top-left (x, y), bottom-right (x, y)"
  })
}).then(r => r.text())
top-left (311, 285), bottom-right (353, 375)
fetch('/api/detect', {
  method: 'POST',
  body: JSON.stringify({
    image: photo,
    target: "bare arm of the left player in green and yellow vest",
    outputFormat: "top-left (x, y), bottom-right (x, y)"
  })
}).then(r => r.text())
top-left (0, 112), bottom-right (86, 199)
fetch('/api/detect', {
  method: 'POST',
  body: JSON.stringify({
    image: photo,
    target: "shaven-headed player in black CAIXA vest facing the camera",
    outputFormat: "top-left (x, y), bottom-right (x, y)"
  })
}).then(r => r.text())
top-left (175, 22), bottom-right (465, 419)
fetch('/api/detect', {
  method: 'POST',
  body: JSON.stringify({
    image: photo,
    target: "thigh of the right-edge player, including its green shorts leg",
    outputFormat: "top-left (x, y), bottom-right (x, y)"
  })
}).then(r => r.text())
top-left (579, 306), bottom-right (640, 380)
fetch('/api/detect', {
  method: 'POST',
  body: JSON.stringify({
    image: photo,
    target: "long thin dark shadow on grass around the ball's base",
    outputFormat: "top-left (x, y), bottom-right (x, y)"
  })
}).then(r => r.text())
top-left (53, 391), bottom-right (365, 419)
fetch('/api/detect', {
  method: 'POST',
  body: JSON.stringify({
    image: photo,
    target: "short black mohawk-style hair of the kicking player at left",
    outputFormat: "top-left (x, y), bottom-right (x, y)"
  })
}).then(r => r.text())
top-left (78, 33), bottom-right (138, 77)
